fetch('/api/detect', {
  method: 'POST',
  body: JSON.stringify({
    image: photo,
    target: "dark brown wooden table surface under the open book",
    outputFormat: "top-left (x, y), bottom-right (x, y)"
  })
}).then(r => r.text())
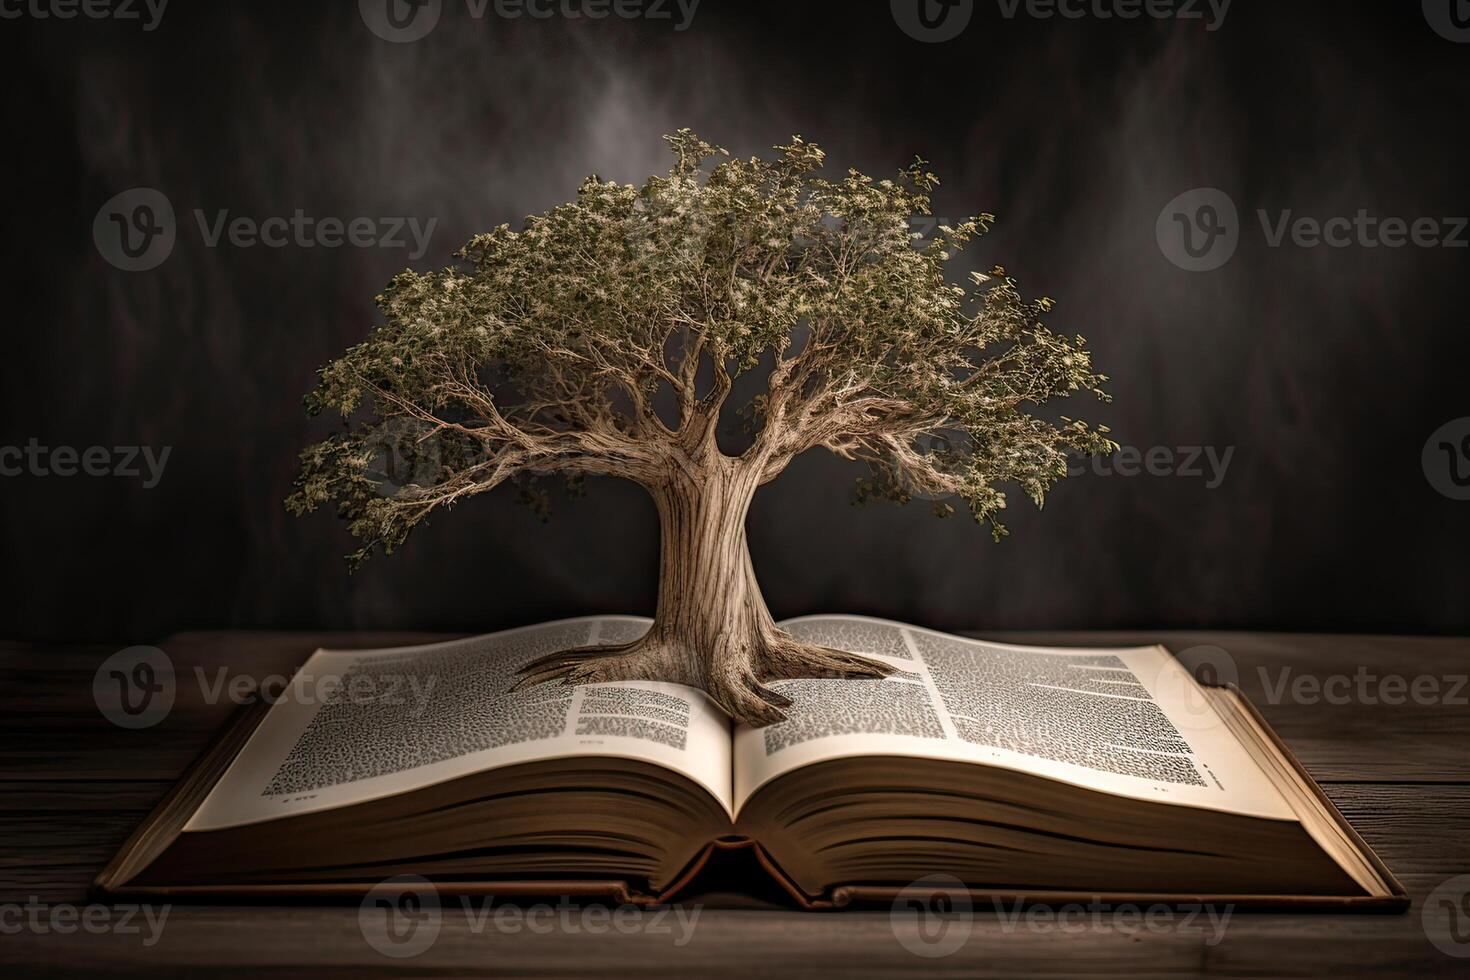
top-left (0, 633), bottom-right (1470, 980)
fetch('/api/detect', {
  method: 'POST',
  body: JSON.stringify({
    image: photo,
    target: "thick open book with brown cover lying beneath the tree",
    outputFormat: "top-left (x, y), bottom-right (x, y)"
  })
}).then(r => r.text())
top-left (98, 616), bottom-right (1407, 908)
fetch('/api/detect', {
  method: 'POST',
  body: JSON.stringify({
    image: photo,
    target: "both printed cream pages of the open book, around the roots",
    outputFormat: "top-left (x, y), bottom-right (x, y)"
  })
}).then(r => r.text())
top-left (190, 617), bottom-right (1292, 830)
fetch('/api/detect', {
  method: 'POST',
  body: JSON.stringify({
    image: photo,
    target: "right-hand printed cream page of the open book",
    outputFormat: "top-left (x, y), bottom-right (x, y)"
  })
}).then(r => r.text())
top-left (735, 616), bottom-right (1295, 820)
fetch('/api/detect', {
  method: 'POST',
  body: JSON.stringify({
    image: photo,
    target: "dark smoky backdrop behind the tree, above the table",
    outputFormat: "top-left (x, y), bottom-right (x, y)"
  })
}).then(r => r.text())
top-left (0, 0), bottom-right (1470, 644)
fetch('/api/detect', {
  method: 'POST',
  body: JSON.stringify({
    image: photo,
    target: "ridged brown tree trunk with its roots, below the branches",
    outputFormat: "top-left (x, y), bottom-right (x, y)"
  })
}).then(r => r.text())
top-left (519, 457), bottom-right (892, 726)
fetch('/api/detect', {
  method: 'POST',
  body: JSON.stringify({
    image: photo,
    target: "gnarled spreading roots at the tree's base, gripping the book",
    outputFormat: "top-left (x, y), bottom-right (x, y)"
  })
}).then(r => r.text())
top-left (513, 633), bottom-right (894, 727)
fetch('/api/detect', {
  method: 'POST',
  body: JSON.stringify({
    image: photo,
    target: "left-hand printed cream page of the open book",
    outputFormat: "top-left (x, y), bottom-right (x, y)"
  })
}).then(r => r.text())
top-left (185, 617), bottom-right (732, 830)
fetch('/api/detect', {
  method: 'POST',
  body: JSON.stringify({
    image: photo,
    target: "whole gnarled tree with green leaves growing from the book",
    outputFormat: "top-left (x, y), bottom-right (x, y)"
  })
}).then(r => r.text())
top-left (287, 129), bottom-right (1116, 724)
